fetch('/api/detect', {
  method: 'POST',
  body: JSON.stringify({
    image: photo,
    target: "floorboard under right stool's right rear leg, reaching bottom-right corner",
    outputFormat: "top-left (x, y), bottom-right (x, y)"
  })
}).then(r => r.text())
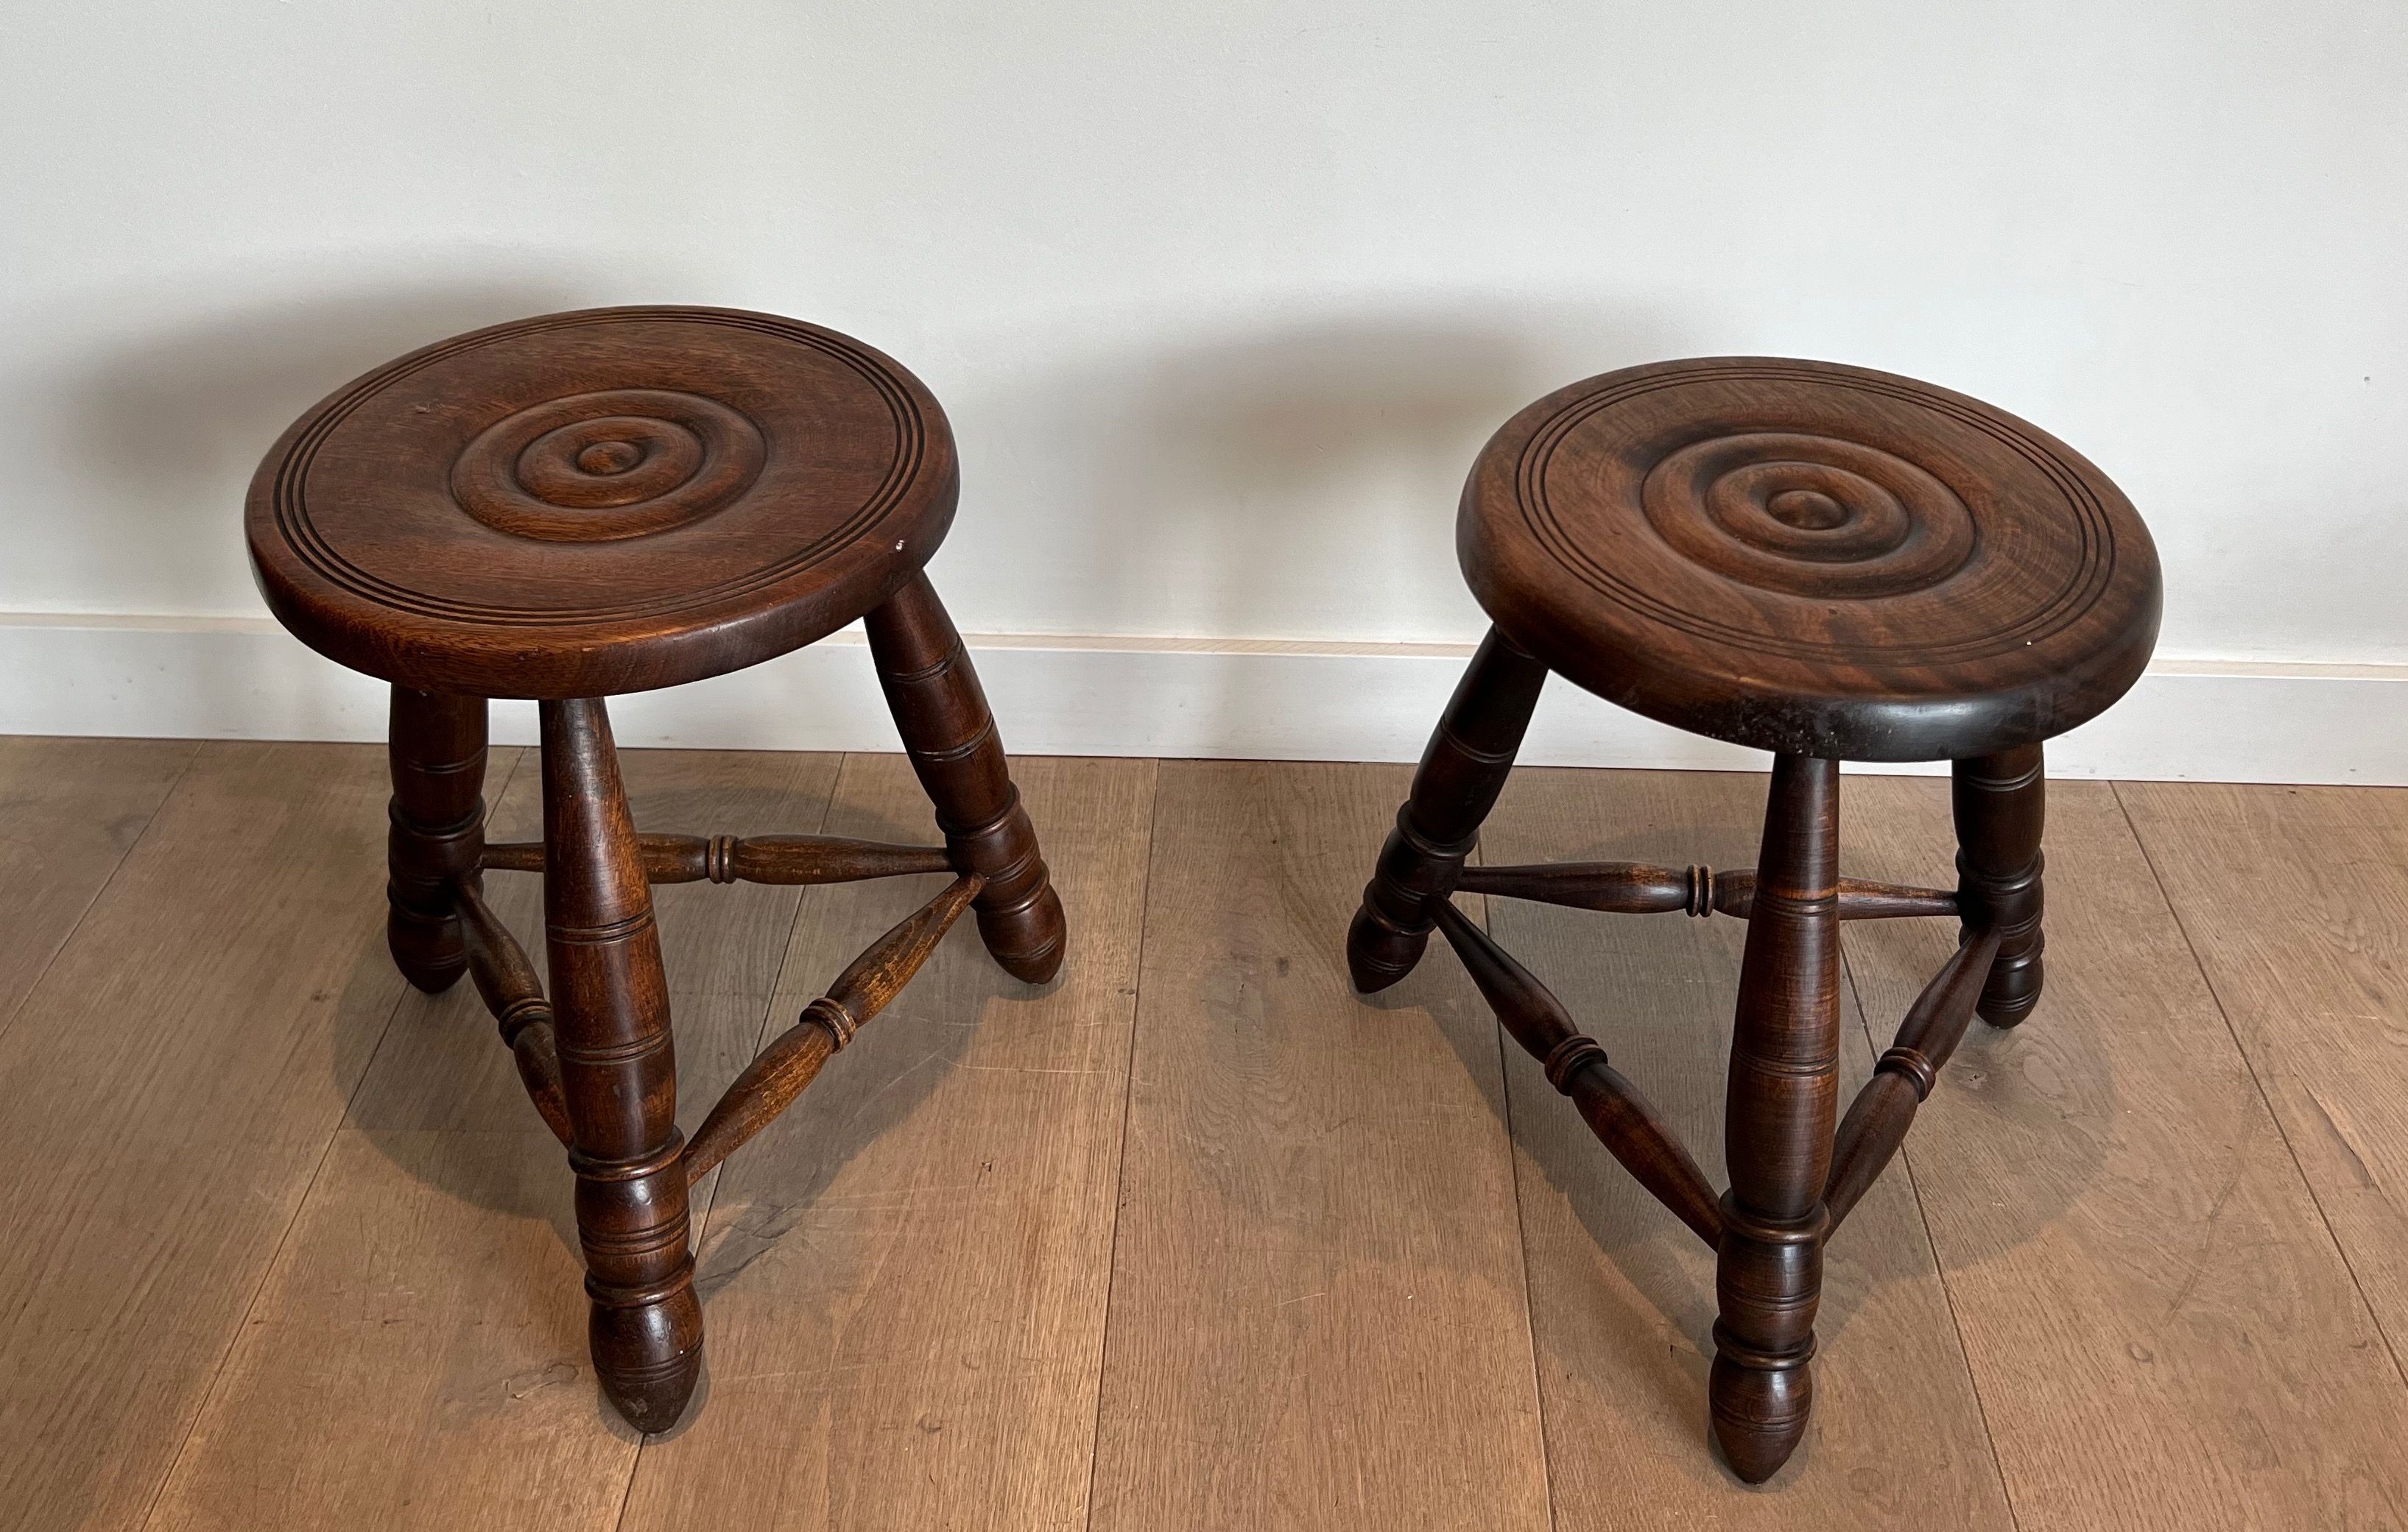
top-left (1840, 776), bottom-right (2408, 1532)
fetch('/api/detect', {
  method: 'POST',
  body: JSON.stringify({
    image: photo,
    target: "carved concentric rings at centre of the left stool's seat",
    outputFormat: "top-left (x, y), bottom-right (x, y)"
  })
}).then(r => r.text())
top-left (453, 388), bottom-right (768, 542)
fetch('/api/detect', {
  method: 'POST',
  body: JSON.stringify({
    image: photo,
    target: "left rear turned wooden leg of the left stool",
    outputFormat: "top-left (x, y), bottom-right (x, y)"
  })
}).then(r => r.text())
top-left (385, 687), bottom-right (484, 995)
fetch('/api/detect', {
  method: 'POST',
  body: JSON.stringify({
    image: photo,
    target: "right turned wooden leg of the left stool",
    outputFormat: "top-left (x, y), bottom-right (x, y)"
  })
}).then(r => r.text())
top-left (867, 573), bottom-right (1064, 985)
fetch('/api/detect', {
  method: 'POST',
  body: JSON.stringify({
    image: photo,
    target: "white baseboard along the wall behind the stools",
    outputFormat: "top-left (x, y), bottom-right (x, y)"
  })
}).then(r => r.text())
top-left (0, 614), bottom-right (2408, 786)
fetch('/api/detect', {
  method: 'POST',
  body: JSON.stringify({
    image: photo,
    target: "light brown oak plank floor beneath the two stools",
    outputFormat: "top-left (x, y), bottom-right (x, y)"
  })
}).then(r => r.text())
top-left (0, 740), bottom-right (2408, 1532)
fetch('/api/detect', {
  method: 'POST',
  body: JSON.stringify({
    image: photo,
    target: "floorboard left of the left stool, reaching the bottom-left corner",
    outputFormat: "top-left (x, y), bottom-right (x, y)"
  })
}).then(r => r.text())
top-left (0, 744), bottom-right (404, 1532)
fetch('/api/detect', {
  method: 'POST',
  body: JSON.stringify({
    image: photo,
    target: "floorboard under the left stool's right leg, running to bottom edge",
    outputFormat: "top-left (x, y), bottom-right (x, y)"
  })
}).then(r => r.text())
top-left (622, 756), bottom-right (1153, 1532)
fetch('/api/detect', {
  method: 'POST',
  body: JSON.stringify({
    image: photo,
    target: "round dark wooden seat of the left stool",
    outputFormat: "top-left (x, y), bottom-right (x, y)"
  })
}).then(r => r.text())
top-left (246, 308), bottom-right (958, 699)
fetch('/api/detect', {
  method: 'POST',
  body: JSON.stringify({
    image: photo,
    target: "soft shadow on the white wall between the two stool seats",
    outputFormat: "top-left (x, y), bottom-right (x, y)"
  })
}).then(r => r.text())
top-left (944, 299), bottom-right (1664, 640)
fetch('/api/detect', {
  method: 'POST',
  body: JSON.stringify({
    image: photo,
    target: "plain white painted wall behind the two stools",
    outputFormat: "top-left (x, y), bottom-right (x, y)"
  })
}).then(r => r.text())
top-left (0, 0), bottom-right (2408, 780)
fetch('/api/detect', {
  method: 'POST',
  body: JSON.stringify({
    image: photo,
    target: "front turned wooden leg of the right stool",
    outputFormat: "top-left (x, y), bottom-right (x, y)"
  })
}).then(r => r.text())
top-left (1710, 756), bottom-right (1840, 1484)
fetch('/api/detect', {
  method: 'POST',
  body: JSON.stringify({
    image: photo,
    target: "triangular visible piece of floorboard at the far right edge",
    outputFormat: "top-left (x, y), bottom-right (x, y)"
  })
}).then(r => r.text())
top-left (2116, 783), bottom-right (2408, 1363)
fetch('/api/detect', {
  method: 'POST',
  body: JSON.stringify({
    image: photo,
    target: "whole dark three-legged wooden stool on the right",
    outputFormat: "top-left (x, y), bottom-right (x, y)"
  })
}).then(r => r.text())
top-left (1346, 359), bottom-right (2160, 1484)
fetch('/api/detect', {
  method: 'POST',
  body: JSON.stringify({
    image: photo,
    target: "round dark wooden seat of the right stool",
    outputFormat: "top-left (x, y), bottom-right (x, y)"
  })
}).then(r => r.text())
top-left (1457, 356), bottom-right (2160, 761)
